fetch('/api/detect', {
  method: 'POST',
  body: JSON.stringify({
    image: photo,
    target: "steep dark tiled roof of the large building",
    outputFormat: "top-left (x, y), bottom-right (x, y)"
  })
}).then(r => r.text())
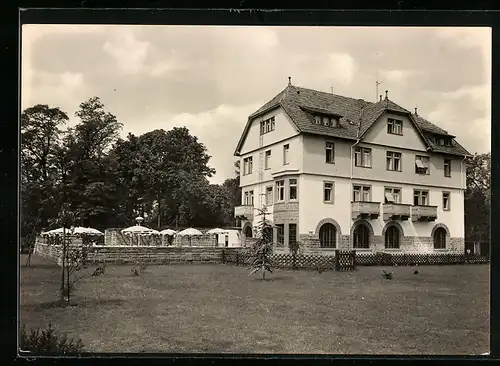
top-left (235, 85), bottom-right (470, 155)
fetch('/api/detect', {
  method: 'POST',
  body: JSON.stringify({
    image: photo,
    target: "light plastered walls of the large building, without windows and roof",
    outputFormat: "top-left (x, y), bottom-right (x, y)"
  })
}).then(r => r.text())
top-left (237, 103), bottom-right (465, 251)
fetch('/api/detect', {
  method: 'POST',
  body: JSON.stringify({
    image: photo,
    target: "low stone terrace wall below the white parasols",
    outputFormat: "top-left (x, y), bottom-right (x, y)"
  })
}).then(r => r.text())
top-left (35, 243), bottom-right (247, 265)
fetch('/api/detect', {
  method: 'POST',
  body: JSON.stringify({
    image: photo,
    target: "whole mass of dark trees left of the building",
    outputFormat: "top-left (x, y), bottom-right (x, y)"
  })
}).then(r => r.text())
top-left (21, 97), bottom-right (241, 246)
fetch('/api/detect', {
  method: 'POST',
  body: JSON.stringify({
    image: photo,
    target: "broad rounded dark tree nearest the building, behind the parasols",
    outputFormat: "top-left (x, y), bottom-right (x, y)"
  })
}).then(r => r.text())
top-left (113, 127), bottom-right (215, 229)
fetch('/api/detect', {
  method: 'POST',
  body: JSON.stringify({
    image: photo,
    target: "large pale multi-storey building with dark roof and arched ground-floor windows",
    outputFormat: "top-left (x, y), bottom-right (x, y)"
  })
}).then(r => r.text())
top-left (235, 83), bottom-right (470, 254)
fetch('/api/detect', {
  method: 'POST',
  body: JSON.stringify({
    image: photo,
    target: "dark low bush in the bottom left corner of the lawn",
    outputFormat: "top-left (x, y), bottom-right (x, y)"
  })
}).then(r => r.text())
top-left (19, 324), bottom-right (83, 354)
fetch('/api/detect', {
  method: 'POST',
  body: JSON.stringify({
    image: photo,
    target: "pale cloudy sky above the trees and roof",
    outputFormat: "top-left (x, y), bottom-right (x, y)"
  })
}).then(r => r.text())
top-left (21, 25), bottom-right (491, 183)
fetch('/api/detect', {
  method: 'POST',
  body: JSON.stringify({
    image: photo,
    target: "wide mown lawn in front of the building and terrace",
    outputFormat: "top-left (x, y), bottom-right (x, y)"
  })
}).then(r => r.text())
top-left (20, 257), bottom-right (489, 355)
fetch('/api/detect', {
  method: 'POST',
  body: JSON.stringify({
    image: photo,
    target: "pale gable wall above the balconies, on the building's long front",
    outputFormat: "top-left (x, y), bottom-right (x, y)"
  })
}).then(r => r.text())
top-left (363, 111), bottom-right (427, 151)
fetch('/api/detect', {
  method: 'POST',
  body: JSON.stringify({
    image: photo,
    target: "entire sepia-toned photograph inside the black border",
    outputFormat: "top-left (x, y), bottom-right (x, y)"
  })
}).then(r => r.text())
top-left (18, 24), bottom-right (492, 356)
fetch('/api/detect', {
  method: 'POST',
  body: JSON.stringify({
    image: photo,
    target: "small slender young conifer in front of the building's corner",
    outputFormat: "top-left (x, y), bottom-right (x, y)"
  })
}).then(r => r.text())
top-left (249, 206), bottom-right (273, 280)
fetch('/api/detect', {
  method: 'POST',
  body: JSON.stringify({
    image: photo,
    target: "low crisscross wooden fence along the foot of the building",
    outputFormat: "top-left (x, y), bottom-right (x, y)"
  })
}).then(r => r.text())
top-left (221, 250), bottom-right (489, 271)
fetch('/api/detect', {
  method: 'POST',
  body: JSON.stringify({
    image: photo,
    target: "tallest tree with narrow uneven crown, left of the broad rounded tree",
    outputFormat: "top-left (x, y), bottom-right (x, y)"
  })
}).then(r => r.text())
top-left (58, 97), bottom-right (122, 227)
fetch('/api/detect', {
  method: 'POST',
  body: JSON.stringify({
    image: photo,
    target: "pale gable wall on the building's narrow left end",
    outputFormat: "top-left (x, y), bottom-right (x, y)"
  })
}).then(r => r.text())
top-left (239, 107), bottom-right (298, 155)
